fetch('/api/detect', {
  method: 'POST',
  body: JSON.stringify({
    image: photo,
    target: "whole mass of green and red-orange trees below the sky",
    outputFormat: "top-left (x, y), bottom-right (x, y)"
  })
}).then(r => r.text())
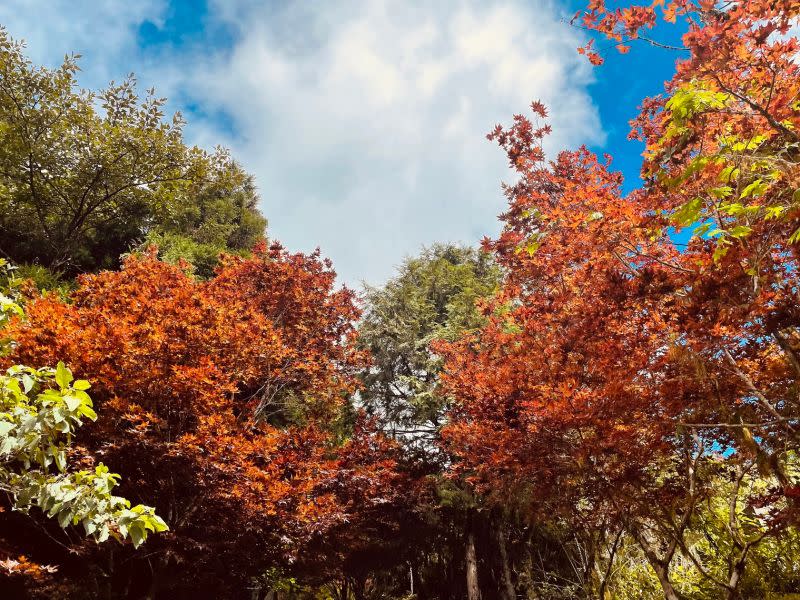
top-left (0, 0), bottom-right (800, 600)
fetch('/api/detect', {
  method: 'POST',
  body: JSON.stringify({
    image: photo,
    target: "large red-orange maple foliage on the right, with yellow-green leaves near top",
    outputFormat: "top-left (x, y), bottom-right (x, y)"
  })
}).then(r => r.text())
top-left (446, 2), bottom-right (800, 598)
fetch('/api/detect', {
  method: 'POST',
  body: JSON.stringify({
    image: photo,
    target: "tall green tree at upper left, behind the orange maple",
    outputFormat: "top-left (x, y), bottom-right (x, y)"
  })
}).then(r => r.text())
top-left (0, 29), bottom-right (265, 275)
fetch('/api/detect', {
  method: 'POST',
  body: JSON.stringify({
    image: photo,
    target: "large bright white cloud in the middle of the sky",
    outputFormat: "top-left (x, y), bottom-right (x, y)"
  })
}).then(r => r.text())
top-left (188, 0), bottom-right (602, 281)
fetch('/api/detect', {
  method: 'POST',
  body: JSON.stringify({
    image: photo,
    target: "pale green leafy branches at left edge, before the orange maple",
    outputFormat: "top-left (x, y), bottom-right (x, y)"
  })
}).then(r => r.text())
top-left (0, 260), bottom-right (167, 600)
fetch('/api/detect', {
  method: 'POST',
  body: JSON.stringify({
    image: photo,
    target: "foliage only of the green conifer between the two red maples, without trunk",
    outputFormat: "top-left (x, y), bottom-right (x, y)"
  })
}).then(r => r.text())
top-left (359, 244), bottom-right (502, 450)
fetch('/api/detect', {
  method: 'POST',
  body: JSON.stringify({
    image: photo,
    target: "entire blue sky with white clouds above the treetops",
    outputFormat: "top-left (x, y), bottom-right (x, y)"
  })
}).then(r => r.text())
top-left (0, 0), bottom-right (678, 285)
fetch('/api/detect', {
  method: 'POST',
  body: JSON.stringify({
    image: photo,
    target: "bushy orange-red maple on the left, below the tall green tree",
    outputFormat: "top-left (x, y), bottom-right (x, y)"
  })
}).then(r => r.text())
top-left (0, 245), bottom-right (400, 597)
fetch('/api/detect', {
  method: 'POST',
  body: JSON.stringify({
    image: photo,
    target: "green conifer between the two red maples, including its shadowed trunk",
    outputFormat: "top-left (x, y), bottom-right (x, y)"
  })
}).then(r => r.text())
top-left (359, 244), bottom-right (505, 598)
